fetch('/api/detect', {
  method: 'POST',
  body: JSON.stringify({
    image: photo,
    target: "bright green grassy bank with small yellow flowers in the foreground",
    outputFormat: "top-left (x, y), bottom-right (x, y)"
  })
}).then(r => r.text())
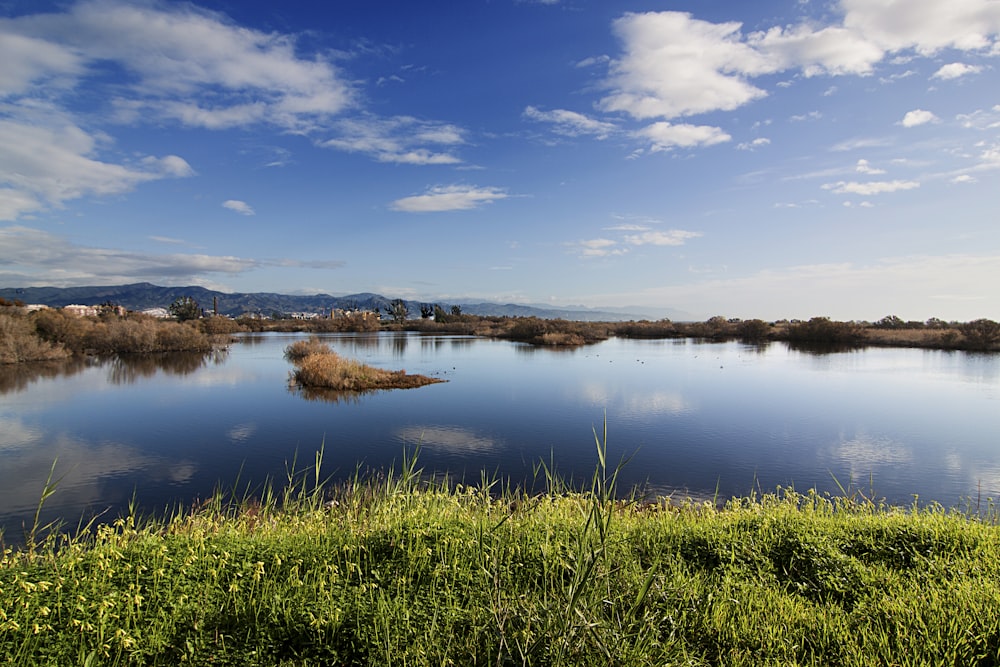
top-left (0, 447), bottom-right (1000, 666)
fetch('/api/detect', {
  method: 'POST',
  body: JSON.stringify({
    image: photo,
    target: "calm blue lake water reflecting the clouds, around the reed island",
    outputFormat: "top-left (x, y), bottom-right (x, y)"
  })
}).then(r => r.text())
top-left (0, 334), bottom-right (1000, 541)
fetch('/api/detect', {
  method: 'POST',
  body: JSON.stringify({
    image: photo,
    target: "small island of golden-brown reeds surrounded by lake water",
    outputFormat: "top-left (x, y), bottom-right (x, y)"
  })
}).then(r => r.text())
top-left (285, 338), bottom-right (447, 392)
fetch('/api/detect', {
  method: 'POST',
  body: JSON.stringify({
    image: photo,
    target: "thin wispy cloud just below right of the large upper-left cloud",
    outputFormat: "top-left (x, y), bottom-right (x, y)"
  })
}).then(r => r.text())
top-left (320, 116), bottom-right (465, 165)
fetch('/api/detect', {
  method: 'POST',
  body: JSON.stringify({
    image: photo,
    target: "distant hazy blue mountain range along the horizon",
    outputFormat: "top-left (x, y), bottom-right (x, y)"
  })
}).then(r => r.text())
top-left (0, 283), bottom-right (681, 321)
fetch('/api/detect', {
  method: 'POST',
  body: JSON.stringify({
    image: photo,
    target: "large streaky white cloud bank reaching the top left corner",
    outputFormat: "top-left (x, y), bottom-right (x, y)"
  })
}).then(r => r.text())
top-left (0, 0), bottom-right (354, 130)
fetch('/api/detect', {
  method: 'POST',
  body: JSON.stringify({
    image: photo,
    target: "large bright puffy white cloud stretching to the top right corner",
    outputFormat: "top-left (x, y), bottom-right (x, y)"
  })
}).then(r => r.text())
top-left (588, 0), bottom-right (1000, 130)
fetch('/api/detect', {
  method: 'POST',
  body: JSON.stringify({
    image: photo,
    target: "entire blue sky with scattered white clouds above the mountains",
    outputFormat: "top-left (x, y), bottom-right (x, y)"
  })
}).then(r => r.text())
top-left (0, 0), bottom-right (1000, 321)
